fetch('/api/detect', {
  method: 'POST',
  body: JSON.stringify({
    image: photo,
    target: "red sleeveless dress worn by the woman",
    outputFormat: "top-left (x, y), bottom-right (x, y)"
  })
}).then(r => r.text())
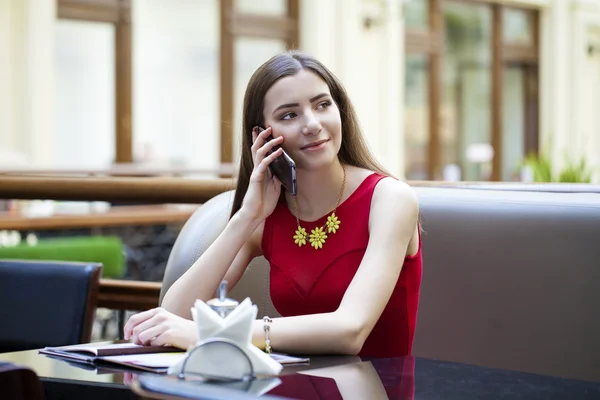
top-left (262, 173), bottom-right (422, 357)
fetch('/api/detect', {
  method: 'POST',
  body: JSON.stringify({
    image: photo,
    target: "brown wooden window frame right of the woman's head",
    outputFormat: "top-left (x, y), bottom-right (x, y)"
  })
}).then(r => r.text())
top-left (404, 0), bottom-right (540, 181)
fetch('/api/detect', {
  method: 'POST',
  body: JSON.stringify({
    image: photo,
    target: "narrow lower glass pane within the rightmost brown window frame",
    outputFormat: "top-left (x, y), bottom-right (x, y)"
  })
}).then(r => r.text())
top-left (501, 67), bottom-right (525, 181)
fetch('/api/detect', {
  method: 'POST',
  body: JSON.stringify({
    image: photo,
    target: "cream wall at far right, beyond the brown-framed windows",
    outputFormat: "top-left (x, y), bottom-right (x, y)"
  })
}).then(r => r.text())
top-left (540, 0), bottom-right (600, 182)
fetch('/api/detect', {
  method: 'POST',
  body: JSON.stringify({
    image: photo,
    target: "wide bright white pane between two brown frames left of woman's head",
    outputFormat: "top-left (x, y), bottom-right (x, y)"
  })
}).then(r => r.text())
top-left (132, 0), bottom-right (220, 175)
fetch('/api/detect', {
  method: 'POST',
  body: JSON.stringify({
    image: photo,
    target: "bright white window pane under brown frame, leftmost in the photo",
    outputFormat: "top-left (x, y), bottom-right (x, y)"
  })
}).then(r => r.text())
top-left (54, 19), bottom-right (115, 169)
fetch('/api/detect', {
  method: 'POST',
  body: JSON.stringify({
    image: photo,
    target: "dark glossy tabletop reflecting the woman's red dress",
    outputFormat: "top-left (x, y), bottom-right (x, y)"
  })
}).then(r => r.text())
top-left (0, 350), bottom-right (600, 400)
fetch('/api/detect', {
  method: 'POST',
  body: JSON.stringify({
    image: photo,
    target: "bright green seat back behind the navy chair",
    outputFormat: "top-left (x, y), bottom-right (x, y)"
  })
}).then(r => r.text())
top-left (0, 236), bottom-right (125, 278)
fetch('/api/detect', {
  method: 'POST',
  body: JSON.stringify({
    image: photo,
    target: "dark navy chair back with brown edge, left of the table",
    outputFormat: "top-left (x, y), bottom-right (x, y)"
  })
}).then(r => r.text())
top-left (0, 260), bottom-right (102, 353)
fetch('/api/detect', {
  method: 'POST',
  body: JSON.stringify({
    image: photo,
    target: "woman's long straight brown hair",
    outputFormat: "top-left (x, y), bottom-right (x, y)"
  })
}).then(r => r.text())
top-left (231, 50), bottom-right (391, 217)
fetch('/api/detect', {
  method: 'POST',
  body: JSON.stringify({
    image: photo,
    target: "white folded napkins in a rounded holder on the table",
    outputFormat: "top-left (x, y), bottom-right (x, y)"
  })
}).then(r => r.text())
top-left (168, 298), bottom-right (283, 377)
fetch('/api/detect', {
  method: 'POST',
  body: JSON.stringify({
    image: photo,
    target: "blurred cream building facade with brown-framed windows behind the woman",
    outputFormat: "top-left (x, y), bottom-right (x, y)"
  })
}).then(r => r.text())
top-left (0, 0), bottom-right (600, 182)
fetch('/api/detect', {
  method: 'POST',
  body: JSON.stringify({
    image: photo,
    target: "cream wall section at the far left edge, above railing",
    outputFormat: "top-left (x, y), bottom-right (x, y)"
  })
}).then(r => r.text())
top-left (0, 0), bottom-right (56, 166)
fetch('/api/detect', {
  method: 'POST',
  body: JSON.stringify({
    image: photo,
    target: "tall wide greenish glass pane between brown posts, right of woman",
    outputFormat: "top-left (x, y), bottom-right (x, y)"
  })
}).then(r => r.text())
top-left (437, 2), bottom-right (493, 180)
